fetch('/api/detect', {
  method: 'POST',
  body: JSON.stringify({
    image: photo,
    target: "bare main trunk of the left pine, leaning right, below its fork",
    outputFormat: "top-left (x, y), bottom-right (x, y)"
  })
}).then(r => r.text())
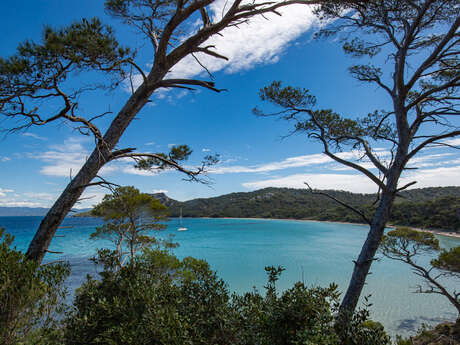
top-left (26, 77), bottom-right (161, 262)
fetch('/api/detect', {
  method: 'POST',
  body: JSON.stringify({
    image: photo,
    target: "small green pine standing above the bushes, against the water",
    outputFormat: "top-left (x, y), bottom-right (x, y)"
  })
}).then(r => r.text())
top-left (91, 187), bottom-right (169, 266)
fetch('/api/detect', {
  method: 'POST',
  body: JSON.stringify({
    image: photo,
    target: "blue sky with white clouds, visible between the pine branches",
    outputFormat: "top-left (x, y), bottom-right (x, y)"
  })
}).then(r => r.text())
top-left (0, 0), bottom-right (460, 207)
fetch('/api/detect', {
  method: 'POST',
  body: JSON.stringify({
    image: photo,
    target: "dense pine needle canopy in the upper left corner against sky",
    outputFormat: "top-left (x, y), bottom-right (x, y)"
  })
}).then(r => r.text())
top-left (0, 18), bottom-right (132, 97)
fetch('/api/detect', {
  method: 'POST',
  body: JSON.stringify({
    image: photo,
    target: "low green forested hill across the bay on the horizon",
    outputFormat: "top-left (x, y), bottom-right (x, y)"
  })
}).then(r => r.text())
top-left (155, 187), bottom-right (460, 230)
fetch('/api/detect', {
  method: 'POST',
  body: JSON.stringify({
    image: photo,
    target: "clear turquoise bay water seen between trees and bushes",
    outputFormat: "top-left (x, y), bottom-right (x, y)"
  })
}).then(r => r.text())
top-left (0, 217), bottom-right (460, 335)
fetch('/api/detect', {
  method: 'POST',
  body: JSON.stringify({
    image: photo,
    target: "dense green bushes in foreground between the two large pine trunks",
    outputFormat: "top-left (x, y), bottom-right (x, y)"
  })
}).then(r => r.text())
top-left (64, 249), bottom-right (389, 345)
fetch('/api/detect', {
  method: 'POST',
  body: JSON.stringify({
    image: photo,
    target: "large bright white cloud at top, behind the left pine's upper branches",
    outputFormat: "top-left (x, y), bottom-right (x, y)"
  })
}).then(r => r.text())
top-left (170, 0), bottom-right (315, 78)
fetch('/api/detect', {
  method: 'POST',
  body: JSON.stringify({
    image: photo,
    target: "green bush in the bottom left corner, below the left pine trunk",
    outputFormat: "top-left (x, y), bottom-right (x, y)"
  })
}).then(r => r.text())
top-left (0, 229), bottom-right (70, 345)
